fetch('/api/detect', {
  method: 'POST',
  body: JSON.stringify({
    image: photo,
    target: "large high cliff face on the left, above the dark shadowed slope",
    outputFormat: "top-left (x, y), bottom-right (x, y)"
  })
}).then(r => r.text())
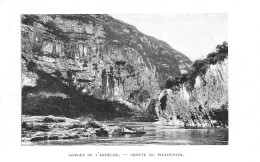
top-left (21, 15), bottom-right (191, 115)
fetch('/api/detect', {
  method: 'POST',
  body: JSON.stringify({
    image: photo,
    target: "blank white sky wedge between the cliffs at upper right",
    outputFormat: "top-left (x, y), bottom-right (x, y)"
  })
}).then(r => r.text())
top-left (111, 13), bottom-right (228, 61)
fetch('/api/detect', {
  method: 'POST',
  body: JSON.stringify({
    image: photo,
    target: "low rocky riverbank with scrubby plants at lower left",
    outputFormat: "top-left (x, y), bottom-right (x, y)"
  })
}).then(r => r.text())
top-left (22, 115), bottom-right (140, 142)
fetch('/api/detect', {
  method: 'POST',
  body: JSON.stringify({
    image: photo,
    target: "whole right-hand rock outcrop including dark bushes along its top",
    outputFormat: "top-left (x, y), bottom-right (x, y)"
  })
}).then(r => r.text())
top-left (156, 42), bottom-right (228, 127)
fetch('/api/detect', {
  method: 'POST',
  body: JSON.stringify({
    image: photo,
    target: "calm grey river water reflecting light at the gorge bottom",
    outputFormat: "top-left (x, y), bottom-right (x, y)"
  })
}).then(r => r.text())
top-left (26, 122), bottom-right (228, 146)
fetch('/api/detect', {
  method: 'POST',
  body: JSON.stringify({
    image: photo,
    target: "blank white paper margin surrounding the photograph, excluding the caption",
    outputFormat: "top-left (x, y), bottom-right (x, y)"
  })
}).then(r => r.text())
top-left (0, 0), bottom-right (260, 162)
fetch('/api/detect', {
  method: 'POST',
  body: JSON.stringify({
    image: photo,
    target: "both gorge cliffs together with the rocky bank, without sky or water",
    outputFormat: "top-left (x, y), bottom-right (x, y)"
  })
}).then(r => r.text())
top-left (21, 14), bottom-right (228, 144)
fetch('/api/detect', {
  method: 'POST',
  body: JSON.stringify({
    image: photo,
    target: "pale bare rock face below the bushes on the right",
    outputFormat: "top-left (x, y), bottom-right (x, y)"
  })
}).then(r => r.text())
top-left (156, 59), bottom-right (228, 128)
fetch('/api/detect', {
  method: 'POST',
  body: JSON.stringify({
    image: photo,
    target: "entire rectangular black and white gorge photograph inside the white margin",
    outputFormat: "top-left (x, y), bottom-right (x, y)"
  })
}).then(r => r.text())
top-left (21, 13), bottom-right (229, 146)
